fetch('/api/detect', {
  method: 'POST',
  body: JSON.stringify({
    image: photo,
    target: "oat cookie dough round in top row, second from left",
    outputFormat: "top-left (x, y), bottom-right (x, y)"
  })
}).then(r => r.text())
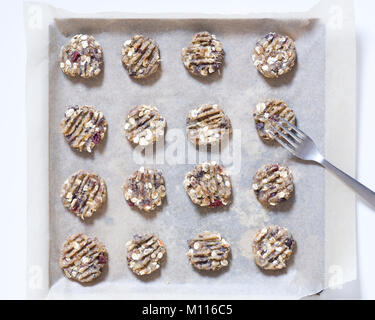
top-left (121, 35), bottom-right (160, 79)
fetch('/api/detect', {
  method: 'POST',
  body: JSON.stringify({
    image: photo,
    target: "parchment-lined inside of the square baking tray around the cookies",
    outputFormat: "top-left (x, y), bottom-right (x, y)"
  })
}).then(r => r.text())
top-left (25, 0), bottom-right (353, 299)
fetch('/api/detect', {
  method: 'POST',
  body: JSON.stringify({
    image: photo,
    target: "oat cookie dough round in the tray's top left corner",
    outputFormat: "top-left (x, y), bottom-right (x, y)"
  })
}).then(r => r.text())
top-left (59, 34), bottom-right (103, 78)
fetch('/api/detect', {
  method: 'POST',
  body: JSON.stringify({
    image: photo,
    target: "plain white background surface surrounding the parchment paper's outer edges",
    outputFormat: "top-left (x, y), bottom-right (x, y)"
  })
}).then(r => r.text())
top-left (0, 0), bottom-right (375, 299)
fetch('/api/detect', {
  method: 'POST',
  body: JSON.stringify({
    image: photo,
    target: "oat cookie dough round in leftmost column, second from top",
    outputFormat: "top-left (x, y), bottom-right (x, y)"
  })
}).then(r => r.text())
top-left (61, 106), bottom-right (108, 153)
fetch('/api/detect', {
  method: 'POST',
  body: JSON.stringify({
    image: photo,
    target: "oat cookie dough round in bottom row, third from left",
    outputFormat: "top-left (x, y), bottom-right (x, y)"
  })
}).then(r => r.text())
top-left (186, 231), bottom-right (230, 271)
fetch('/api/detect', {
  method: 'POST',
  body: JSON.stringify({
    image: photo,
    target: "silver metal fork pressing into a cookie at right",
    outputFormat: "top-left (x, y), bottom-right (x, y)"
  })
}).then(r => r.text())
top-left (267, 118), bottom-right (375, 206)
